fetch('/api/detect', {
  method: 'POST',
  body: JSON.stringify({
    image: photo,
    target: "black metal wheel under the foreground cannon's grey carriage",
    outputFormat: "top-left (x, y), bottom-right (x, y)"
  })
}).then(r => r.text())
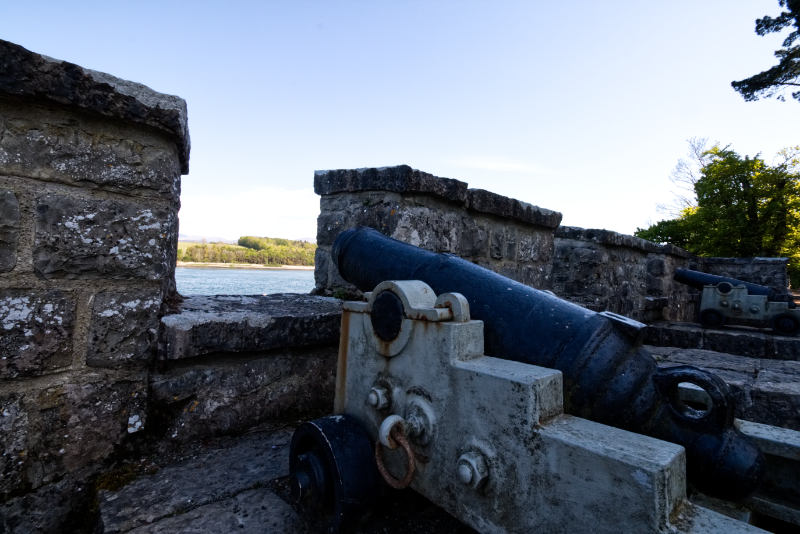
top-left (289, 415), bottom-right (380, 534)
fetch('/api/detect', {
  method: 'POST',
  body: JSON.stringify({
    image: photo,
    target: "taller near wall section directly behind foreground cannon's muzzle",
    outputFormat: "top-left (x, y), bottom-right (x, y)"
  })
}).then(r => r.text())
top-left (314, 165), bottom-right (561, 296)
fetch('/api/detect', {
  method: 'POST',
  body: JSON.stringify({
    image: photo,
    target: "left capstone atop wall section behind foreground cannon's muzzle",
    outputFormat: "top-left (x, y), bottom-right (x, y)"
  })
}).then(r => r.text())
top-left (314, 165), bottom-right (467, 204)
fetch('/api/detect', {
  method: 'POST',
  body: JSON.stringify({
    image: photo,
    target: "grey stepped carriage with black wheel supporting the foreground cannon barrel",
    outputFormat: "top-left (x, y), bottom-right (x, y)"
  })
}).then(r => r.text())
top-left (289, 280), bottom-right (763, 534)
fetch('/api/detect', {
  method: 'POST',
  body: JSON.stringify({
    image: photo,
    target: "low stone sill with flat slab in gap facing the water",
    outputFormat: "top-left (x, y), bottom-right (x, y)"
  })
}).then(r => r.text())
top-left (151, 293), bottom-right (342, 442)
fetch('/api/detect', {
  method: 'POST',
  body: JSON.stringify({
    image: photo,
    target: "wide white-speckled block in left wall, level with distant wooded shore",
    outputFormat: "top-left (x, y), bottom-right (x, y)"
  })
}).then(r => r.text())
top-left (33, 195), bottom-right (177, 280)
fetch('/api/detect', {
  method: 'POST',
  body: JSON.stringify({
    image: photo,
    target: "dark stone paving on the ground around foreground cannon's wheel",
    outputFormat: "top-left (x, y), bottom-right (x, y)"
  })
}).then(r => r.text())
top-left (95, 427), bottom-right (475, 534)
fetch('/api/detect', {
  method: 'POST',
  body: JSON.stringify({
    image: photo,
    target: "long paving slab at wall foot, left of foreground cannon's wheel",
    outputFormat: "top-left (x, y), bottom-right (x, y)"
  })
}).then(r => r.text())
top-left (98, 430), bottom-right (291, 534)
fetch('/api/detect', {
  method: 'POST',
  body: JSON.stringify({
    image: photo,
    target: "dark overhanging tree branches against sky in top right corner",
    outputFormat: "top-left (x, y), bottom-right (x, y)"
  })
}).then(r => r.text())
top-left (731, 0), bottom-right (800, 102)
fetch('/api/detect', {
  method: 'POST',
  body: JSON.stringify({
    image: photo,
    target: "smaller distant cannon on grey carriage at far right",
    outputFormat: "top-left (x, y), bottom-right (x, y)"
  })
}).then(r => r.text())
top-left (674, 269), bottom-right (800, 336)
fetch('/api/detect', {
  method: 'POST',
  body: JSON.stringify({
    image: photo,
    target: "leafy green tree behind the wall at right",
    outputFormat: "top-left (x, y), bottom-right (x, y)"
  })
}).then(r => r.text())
top-left (635, 145), bottom-right (800, 284)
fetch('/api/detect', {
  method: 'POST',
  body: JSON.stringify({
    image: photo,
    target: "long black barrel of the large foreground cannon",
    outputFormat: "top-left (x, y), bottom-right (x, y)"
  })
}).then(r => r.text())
top-left (332, 227), bottom-right (765, 500)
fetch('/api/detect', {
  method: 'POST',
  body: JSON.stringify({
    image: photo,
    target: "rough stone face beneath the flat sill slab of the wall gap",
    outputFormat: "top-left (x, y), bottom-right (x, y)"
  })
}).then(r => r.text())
top-left (151, 343), bottom-right (338, 442)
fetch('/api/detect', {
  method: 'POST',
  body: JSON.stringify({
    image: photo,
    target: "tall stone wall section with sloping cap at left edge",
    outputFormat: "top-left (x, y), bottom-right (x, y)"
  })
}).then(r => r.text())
top-left (0, 41), bottom-right (189, 532)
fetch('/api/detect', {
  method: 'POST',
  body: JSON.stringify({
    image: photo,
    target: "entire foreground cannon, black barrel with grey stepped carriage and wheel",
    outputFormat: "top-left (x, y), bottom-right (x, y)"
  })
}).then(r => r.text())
top-left (290, 228), bottom-right (764, 532)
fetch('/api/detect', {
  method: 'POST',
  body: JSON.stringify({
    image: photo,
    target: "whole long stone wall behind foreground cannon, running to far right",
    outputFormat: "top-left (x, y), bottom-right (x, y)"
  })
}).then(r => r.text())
top-left (314, 165), bottom-right (788, 322)
